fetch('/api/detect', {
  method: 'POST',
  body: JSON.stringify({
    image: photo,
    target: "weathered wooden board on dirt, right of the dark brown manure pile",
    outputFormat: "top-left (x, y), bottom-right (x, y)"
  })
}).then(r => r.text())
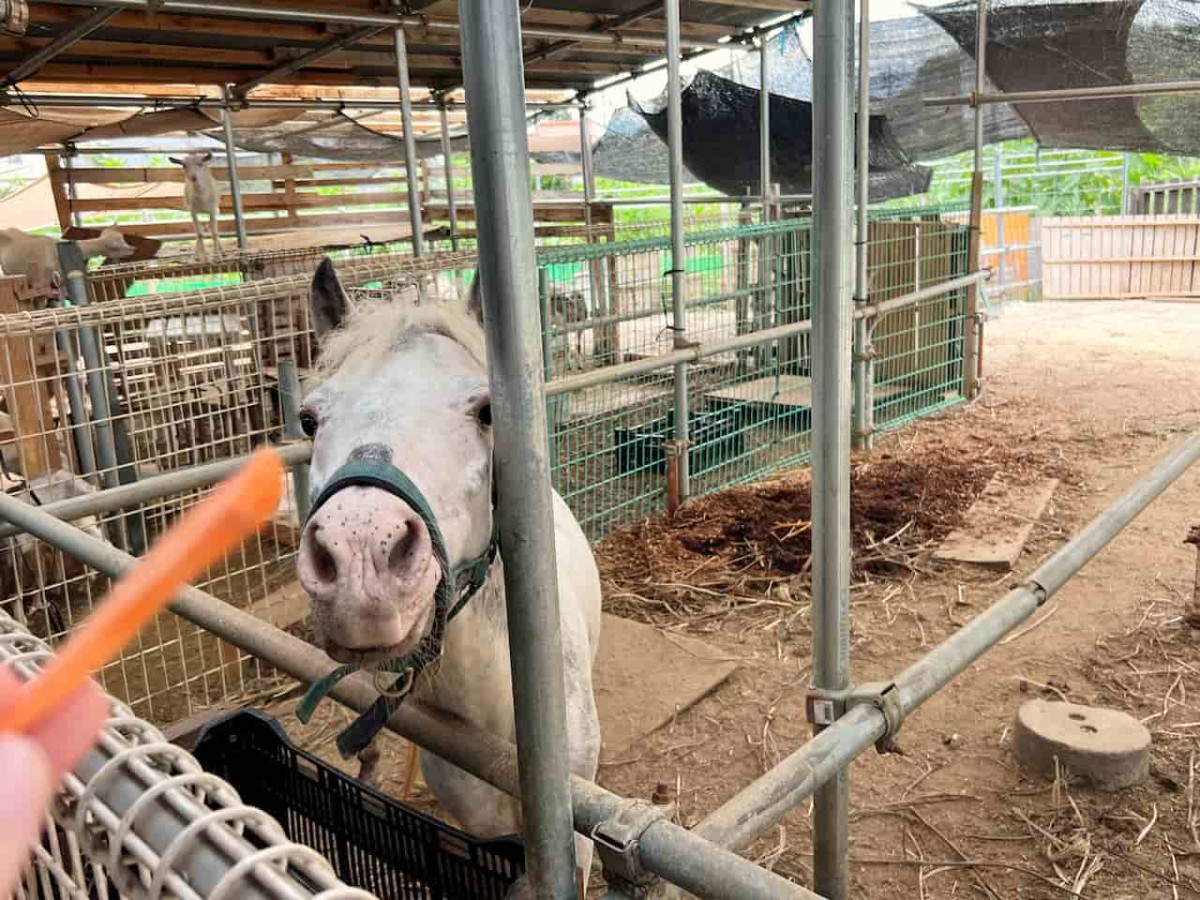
top-left (934, 475), bottom-right (1058, 571)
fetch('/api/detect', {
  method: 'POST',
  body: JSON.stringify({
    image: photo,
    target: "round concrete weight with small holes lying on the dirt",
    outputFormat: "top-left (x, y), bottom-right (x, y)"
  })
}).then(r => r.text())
top-left (1013, 700), bottom-right (1150, 791)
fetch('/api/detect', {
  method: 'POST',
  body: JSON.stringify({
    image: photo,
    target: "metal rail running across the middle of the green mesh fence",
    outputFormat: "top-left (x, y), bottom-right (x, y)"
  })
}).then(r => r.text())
top-left (546, 269), bottom-right (991, 397)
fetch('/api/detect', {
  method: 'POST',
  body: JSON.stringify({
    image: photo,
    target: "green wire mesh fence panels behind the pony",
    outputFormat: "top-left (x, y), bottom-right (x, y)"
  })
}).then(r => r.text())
top-left (539, 208), bottom-right (967, 539)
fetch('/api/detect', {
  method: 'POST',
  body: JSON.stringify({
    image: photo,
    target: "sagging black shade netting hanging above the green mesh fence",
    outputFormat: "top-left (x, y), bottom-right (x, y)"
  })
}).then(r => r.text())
top-left (630, 71), bottom-right (930, 199)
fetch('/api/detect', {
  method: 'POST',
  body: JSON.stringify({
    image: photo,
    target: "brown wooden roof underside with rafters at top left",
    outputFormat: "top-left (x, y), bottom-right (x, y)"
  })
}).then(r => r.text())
top-left (0, 0), bottom-right (808, 95)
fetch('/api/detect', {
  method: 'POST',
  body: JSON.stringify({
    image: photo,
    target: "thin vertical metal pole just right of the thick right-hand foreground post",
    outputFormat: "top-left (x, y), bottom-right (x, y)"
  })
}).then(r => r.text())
top-left (851, 0), bottom-right (873, 450)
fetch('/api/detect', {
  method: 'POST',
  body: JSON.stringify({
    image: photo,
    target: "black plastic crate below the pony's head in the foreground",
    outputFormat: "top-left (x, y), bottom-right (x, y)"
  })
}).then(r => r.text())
top-left (193, 710), bottom-right (524, 900)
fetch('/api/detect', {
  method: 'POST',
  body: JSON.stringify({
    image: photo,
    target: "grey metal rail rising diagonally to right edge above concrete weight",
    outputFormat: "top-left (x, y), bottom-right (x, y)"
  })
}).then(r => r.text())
top-left (695, 433), bottom-right (1200, 848)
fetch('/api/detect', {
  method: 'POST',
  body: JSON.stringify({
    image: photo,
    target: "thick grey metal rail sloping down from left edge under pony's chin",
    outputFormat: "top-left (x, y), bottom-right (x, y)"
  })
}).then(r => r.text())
top-left (0, 493), bottom-right (820, 900)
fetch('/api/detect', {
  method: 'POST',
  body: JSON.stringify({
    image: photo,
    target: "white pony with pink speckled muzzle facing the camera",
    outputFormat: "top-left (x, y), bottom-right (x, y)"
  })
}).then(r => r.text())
top-left (298, 259), bottom-right (600, 895)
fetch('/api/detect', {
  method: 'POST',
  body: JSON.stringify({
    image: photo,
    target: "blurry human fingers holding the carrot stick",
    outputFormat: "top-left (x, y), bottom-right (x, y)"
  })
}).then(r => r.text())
top-left (0, 665), bottom-right (108, 898)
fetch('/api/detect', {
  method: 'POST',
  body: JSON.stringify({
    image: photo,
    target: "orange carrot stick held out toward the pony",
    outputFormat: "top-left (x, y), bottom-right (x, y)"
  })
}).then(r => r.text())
top-left (0, 449), bottom-right (283, 733)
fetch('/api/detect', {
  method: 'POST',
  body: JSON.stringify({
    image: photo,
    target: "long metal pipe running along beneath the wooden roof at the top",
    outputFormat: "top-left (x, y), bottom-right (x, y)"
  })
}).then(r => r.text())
top-left (34, 0), bottom-right (725, 50)
